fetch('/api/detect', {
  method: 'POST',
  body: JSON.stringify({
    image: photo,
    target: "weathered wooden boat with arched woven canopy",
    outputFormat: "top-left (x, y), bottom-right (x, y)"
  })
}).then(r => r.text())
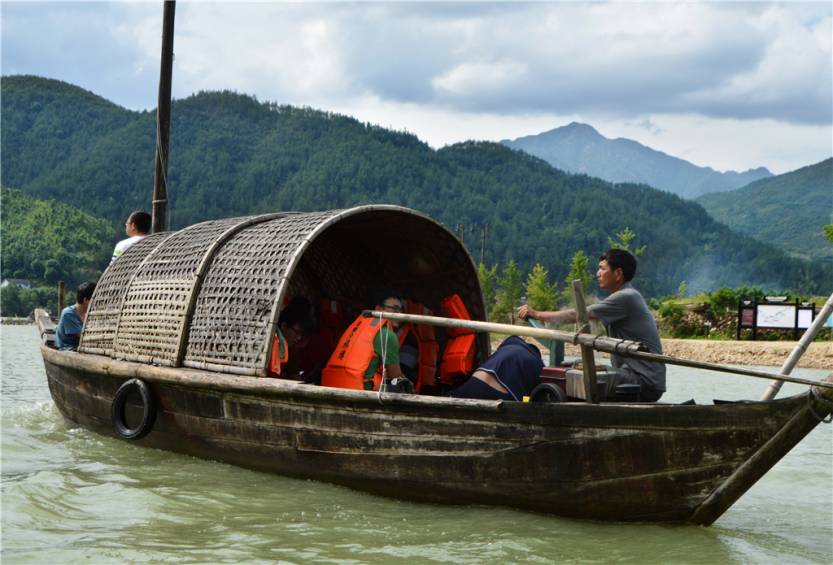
top-left (41, 206), bottom-right (833, 524)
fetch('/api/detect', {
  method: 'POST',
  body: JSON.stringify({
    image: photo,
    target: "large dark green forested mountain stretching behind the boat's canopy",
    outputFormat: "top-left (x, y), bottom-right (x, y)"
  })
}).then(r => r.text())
top-left (2, 77), bottom-right (831, 295)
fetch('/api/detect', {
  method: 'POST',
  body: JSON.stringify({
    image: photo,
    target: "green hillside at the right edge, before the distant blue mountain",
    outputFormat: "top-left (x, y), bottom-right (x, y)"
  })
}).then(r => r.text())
top-left (697, 159), bottom-right (833, 262)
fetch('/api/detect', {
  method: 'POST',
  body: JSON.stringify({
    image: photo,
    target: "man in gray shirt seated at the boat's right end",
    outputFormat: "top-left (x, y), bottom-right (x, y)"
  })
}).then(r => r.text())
top-left (518, 249), bottom-right (665, 402)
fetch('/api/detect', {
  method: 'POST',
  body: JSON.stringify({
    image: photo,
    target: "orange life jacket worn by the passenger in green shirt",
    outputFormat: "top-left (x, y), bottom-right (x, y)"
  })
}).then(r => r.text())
top-left (321, 316), bottom-right (390, 390)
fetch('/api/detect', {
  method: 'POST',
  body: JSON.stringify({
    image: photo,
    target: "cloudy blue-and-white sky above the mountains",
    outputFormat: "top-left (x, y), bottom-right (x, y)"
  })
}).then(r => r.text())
top-left (0, 0), bottom-right (833, 173)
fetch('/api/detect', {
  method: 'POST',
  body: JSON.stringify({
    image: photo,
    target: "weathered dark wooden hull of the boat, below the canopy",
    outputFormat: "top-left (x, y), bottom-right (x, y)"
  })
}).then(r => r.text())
top-left (42, 347), bottom-right (828, 521)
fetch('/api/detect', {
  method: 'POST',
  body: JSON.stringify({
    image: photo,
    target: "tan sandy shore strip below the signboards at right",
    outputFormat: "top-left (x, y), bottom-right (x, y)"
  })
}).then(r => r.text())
top-left (565, 339), bottom-right (833, 371)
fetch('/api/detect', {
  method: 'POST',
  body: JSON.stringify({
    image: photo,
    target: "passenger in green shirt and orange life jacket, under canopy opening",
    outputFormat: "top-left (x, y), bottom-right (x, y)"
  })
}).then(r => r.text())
top-left (321, 290), bottom-right (405, 390)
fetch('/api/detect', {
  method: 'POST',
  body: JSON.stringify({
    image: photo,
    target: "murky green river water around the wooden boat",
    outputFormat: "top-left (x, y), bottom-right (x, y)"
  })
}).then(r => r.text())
top-left (0, 326), bottom-right (833, 565)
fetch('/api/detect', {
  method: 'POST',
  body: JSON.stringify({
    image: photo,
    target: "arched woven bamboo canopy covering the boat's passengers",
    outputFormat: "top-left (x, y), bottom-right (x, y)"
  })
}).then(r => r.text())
top-left (79, 205), bottom-right (489, 376)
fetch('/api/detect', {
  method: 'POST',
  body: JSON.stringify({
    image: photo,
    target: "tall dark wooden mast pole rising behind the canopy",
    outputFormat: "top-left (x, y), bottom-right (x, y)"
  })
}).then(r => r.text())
top-left (151, 0), bottom-right (176, 233)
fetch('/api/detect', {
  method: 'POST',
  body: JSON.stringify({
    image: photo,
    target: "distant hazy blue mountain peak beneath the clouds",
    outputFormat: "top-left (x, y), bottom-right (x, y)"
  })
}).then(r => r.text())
top-left (501, 122), bottom-right (772, 199)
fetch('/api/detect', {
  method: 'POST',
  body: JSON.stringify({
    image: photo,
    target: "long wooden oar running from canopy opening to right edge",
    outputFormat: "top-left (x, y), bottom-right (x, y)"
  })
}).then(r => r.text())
top-left (363, 310), bottom-right (833, 390)
